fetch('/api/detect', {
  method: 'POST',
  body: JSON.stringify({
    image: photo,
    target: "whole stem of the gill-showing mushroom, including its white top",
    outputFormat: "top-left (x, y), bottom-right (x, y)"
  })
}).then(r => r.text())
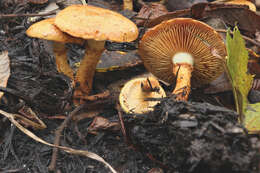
top-left (172, 52), bottom-right (194, 101)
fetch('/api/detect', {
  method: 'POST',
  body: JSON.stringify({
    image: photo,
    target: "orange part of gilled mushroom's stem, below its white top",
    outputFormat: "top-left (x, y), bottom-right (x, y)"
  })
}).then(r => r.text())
top-left (172, 63), bottom-right (193, 101)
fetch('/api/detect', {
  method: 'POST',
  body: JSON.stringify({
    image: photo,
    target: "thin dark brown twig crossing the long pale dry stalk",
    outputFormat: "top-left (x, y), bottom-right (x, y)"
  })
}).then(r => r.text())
top-left (48, 104), bottom-right (85, 171)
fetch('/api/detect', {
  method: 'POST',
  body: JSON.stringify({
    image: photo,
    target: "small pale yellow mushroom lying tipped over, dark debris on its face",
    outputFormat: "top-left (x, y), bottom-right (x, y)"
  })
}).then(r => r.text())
top-left (119, 77), bottom-right (166, 114)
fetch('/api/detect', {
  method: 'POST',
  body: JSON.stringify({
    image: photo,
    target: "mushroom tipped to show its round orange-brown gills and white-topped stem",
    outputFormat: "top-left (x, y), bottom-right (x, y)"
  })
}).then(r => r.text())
top-left (138, 18), bottom-right (226, 100)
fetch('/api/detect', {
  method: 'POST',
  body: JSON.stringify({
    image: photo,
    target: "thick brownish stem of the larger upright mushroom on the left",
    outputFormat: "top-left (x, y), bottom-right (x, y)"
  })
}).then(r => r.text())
top-left (74, 40), bottom-right (105, 97)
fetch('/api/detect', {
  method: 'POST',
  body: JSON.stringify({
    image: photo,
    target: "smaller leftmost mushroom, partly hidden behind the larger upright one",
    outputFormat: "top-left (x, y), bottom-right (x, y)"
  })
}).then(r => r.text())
top-left (26, 18), bottom-right (84, 79)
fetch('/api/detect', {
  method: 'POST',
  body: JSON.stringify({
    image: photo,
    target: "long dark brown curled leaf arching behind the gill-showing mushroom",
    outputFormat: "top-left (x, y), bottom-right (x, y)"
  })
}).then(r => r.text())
top-left (146, 3), bottom-right (260, 37)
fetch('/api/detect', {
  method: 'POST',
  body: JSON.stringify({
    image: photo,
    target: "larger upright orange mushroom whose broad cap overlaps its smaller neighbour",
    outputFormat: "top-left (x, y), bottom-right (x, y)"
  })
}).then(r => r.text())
top-left (55, 5), bottom-right (138, 98)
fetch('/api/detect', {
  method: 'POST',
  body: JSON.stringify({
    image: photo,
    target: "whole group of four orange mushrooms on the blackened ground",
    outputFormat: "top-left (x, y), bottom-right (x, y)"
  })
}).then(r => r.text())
top-left (26, 5), bottom-right (226, 114)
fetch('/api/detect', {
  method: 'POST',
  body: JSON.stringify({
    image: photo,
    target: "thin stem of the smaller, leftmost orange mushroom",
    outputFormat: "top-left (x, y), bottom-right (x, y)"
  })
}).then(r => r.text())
top-left (53, 42), bottom-right (73, 79)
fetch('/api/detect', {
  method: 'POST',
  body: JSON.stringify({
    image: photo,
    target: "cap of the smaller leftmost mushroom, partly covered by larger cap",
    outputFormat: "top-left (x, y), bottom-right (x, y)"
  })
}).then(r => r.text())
top-left (26, 18), bottom-right (84, 44)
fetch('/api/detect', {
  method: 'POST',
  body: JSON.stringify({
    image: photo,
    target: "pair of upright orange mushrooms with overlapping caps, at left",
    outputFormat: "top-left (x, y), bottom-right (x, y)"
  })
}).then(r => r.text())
top-left (26, 5), bottom-right (138, 103)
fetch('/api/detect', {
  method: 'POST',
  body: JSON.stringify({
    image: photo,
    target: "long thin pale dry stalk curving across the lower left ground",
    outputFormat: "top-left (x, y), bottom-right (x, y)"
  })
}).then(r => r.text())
top-left (0, 110), bottom-right (117, 173)
